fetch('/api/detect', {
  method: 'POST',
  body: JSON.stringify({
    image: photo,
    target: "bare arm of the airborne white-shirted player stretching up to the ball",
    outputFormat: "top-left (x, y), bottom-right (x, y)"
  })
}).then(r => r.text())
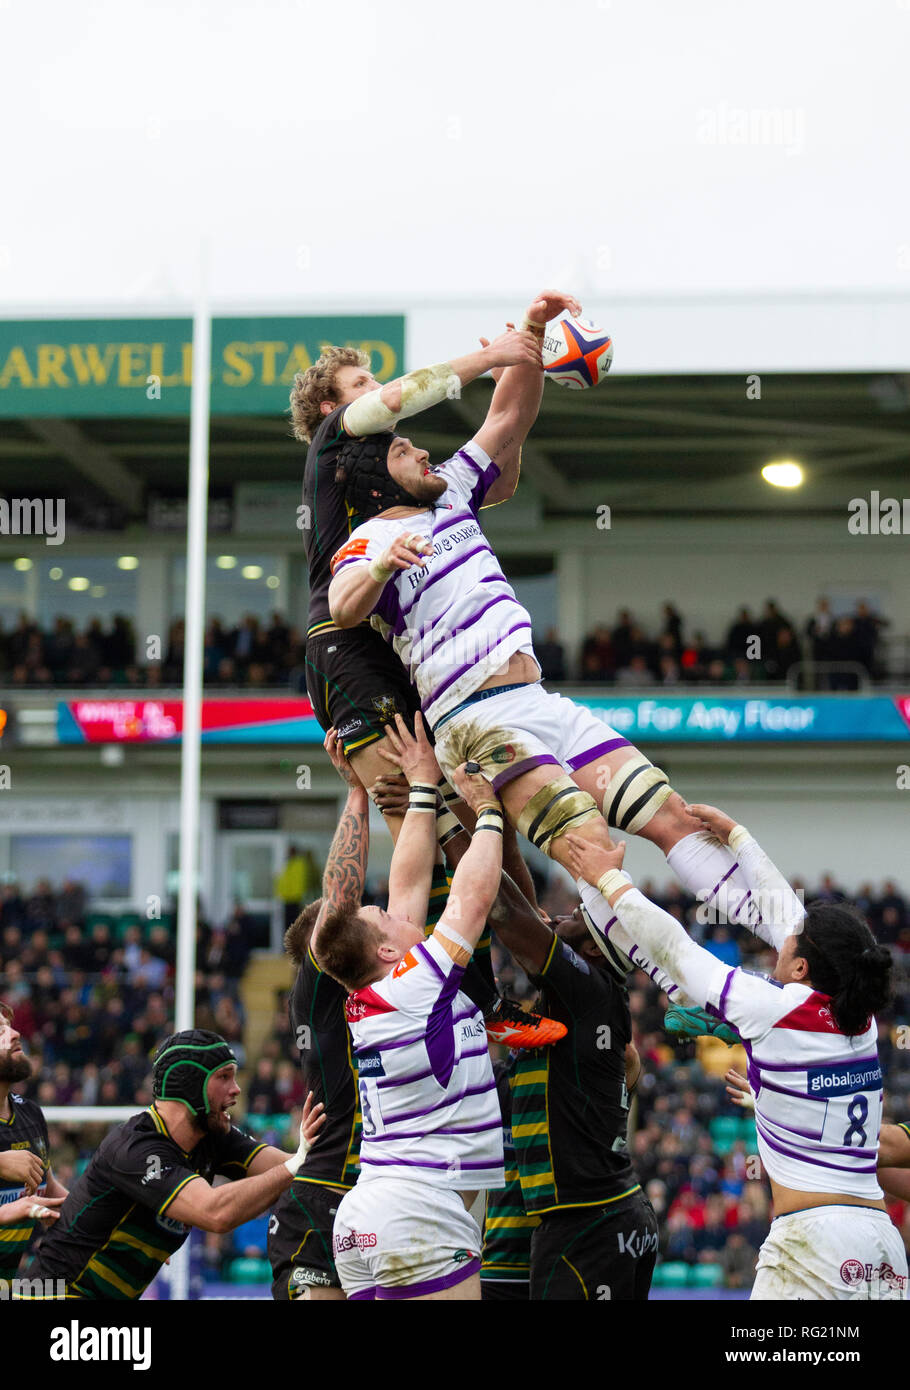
top-left (474, 289), bottom-right (581, 506)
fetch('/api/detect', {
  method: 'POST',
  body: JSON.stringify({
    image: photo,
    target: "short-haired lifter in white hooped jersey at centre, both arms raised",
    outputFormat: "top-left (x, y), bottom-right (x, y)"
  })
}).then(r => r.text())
top-left (318, 714), bottom-right (504, 1300)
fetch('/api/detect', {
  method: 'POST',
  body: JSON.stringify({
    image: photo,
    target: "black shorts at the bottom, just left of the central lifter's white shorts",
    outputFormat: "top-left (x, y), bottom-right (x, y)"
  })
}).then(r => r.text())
top-left (268, 1182), bottom-right (343, 1302)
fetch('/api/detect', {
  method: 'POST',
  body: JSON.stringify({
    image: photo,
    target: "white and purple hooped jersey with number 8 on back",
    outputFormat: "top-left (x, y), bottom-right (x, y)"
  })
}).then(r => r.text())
top-left (707, 967), bottom-right (882, 1200)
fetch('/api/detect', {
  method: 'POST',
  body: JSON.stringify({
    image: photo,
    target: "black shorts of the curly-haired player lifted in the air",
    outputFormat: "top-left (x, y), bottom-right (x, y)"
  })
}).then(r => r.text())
top-left (306, 623), bottom-right (420, 753)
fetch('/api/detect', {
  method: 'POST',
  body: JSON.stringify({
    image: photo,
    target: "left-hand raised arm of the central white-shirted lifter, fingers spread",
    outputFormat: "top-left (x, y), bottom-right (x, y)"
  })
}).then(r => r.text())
top-left (379, 713), bottom-right (439, 927)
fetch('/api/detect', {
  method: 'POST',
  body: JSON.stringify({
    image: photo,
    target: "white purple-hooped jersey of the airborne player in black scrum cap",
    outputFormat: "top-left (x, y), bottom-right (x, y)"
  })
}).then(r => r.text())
top-left (332, 441), bottom-right (533, 726)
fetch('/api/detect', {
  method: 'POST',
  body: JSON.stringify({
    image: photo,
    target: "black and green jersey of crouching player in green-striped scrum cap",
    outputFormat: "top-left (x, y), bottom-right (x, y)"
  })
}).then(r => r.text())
top-left (26, 1106), bottom-right (267, 1300)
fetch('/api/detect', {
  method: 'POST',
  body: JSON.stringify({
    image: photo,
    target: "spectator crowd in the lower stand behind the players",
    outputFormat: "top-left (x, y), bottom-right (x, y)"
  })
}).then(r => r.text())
top-left (0, 876), bottom-right (910, 1289)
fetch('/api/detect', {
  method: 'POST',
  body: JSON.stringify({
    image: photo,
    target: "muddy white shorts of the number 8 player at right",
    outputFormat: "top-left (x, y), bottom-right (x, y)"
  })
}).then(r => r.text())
top-left (752, 1205), bottom-right (907, 1302)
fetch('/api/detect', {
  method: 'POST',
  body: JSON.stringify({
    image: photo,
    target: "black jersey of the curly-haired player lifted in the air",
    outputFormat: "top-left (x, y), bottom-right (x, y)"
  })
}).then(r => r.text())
top-left (303, 406), bottom-right (351, 635)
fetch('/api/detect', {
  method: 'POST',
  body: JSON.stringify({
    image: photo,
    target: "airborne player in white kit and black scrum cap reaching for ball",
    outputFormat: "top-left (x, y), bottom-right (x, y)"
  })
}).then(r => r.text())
top-left (328, 333), bottom-right (759, 924)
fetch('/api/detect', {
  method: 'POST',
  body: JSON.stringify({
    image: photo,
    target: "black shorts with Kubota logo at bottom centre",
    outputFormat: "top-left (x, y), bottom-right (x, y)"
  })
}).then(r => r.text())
top-left (531, 1191), bottom-right (659, 1302)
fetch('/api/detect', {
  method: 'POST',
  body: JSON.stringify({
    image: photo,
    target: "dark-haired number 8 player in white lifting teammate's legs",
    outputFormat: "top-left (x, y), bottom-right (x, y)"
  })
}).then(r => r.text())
top-left (567, 806), bottom-right (907, 1300)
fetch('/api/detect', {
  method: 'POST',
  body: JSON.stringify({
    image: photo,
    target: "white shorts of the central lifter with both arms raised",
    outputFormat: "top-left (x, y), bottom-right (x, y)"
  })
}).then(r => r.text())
top-left (332, 1177), bottom-right (483, 1298)
